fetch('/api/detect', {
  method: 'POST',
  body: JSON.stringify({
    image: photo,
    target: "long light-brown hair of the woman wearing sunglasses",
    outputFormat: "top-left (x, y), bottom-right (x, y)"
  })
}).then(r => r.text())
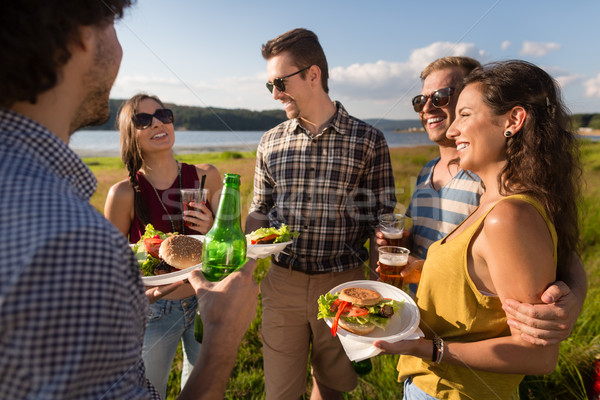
top-left (117, 93), bottom-right (165, 225)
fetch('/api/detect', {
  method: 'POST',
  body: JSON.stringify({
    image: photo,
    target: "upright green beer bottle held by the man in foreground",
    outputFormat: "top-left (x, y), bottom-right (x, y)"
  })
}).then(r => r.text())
top-left (194, 174), bottom-right (246, 342)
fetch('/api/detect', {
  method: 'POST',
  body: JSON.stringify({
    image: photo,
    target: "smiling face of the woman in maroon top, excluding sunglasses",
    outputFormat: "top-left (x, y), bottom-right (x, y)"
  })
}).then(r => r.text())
top-left (136, 99), bottom-right (175, 153)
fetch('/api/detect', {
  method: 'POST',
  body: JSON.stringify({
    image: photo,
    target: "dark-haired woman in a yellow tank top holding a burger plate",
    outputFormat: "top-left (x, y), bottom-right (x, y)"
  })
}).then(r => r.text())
top-left (375, 61), bottom-right (581, 399)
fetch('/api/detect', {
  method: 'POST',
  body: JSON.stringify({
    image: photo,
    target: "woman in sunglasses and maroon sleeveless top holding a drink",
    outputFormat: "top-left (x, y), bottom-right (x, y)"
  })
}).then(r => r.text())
top-left (104, 94), bottom-right (221, 398)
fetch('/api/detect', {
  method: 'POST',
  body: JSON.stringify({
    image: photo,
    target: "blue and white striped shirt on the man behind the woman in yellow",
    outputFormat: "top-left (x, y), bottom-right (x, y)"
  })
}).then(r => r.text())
top-left (406, 157), bottom-right (483, 258)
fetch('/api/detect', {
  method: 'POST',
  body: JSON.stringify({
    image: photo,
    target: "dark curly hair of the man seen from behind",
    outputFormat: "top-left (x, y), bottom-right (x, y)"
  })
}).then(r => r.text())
top-left (0, 0), bottom-right (135, 107)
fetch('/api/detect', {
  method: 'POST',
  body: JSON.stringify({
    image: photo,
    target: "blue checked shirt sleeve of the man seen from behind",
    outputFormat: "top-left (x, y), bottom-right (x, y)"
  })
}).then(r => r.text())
top-left (0, 226), bottom-right (158, 399)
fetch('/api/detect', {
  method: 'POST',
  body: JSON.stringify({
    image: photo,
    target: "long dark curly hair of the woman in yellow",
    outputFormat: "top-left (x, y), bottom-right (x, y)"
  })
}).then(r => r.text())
top-left (464, 60), bottom-right (582, 266)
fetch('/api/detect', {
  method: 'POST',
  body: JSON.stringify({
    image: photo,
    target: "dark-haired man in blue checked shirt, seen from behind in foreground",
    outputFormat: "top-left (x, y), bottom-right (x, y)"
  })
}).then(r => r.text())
top-left (0, 0), bottom-right (258, 400)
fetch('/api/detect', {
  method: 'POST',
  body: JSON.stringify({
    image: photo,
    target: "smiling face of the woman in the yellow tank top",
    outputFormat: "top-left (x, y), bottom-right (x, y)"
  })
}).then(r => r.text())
top-left (447, 83), bottom-right (508, 174)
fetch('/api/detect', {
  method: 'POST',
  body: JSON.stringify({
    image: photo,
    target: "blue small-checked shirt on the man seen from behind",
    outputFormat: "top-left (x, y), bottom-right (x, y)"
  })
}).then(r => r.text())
top-left (0, 108), bottom-right (159, 399)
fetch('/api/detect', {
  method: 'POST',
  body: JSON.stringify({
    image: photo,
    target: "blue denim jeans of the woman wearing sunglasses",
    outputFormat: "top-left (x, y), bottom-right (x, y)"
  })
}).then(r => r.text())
top-left (142, 296), bottom-right (200, 399)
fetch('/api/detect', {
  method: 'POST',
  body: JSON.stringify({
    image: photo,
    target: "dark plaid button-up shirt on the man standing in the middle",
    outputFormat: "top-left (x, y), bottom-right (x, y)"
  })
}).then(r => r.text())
top-left (250, 102), bottom-right (396, 272)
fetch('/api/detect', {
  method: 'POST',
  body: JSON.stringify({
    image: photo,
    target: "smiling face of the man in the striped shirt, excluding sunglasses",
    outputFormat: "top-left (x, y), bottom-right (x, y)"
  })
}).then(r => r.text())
top-left (419, 68), bottom-right (465, 146)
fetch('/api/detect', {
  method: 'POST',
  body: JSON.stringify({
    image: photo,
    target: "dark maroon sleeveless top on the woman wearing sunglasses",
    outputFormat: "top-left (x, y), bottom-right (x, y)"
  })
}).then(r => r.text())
top-left (129, 163), bottom-right (205, 243)
